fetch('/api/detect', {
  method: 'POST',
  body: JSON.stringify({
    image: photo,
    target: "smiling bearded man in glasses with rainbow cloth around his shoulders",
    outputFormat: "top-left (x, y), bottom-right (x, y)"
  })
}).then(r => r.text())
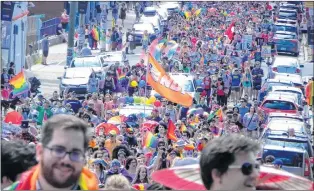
top-left (7, 114), bottom-right (98, 190)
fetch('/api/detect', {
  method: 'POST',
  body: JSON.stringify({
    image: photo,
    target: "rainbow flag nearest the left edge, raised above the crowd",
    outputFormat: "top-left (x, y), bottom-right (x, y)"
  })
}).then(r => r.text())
top-left (9, 72), bottom-right (29, 97)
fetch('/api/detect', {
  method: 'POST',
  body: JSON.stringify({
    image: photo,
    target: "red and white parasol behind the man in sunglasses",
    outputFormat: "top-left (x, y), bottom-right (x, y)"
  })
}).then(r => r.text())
top-left (152, 164), bottom-right (314, 190)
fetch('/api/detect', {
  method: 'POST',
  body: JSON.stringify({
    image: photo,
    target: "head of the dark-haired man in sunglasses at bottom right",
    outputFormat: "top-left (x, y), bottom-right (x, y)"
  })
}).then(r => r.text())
top-left (200, 134), bottom-right (260, 190)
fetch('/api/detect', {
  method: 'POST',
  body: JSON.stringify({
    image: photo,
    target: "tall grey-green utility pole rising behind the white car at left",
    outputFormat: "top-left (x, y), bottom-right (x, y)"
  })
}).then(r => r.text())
top-left (67, 1), bottom-right (78, 66)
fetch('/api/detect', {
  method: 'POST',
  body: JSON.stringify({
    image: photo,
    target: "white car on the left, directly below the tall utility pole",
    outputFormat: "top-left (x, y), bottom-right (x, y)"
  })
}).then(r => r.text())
top-left (58, 67), bottom-right (93, 98)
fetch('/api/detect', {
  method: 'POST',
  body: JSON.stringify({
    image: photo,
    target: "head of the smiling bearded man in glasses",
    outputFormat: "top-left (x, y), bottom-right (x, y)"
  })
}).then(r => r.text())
top-left (36, 114), bottom-right (88, 188)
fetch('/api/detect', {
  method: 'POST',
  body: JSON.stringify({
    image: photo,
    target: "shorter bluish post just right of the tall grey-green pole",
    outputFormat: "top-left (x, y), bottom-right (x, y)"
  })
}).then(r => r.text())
top-left (77, 1), bottom-right (89, 53)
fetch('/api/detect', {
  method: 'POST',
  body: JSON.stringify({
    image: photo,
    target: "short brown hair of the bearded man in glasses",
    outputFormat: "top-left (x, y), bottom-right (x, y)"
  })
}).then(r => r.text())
top-left (41, 114), bottom-right (89, 149)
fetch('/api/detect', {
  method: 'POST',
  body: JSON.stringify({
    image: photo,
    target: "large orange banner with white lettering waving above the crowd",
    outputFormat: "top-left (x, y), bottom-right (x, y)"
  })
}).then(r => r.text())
top-left (147, 53), bottom-right (193, 107)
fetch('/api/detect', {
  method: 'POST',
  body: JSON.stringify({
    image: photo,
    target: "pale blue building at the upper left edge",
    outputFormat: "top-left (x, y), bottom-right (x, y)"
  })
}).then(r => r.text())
top-left (1, 1), bottom-right (29, 73)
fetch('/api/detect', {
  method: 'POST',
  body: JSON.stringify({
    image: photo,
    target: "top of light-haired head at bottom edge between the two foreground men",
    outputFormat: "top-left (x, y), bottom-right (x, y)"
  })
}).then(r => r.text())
top-left (104, 174), bottom-right (132, 190)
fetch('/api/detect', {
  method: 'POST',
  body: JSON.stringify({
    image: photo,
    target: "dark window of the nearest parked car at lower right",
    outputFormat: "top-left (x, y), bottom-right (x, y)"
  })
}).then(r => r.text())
top-left (263, 149), bottom-right (303, 167)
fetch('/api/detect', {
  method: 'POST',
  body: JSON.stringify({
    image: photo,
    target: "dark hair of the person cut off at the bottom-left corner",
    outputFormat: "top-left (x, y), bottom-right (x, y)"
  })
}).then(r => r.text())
top-left (1, 141), bottom-right (37, 182)
